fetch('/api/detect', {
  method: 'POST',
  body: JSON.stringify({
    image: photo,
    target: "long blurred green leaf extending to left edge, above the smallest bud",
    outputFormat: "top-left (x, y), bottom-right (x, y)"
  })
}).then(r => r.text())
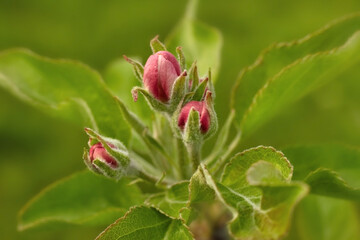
top-left (0, 49), bottom-right (130, 143)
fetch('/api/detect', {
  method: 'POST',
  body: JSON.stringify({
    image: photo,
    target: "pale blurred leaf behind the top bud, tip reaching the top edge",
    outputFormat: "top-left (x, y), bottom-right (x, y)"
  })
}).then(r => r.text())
top-left (166, 0), bottom-right (222, 82)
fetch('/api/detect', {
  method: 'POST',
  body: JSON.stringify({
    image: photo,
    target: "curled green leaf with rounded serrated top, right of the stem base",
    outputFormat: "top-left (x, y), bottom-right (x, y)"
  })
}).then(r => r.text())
top-left (216, 146), bottom-right (308, 239)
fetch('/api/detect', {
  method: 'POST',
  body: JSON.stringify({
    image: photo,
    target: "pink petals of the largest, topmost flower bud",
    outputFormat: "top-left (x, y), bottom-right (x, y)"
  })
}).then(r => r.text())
top-left (143, 51), bottom-right (181, 102)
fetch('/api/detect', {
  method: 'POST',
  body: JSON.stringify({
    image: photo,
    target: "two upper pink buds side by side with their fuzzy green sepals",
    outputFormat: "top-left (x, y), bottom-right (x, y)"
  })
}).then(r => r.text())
top-left (125, 37), bottom-right (217, 143)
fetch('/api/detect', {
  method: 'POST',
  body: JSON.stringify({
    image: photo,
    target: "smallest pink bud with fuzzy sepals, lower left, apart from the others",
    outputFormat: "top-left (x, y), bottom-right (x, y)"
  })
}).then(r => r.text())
top-left (83, 128), bottom-right (130, 180)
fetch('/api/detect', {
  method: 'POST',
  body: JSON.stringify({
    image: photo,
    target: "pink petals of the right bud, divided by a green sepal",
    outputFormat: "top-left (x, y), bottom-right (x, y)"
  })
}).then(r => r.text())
top-left (178, 101), bottom-right (210, 133)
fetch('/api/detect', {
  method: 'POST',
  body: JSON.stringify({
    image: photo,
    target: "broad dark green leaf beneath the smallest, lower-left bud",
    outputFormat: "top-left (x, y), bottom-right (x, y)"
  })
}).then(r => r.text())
top-left (18, 171), bottom-right (143, 230)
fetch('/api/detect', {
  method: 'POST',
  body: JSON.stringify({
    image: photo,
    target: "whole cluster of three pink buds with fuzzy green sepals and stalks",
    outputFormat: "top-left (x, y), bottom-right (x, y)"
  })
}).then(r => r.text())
top-left (84, 37), bottom-right (218, 180)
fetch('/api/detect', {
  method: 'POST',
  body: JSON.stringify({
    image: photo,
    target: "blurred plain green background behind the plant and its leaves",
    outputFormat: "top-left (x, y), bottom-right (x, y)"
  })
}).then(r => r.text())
top-left (0, 0), bottom-right (360, 239)
